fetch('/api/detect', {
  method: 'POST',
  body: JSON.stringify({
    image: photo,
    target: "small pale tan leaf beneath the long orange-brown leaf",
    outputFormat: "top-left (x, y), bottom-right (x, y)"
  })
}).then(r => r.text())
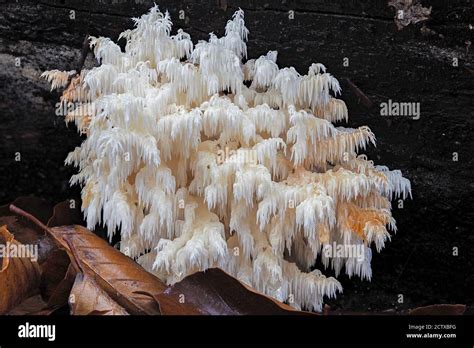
top-left (69, 273), bottom-right (128, 315)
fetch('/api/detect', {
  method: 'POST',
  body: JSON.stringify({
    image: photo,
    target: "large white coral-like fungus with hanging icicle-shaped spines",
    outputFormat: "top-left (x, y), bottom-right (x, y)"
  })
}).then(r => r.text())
top-left (42, 5), bottom-right (411, 311)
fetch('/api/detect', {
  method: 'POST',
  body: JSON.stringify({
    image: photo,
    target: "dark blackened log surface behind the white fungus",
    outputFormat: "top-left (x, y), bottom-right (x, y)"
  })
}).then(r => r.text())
top-left (0, 0), bottom-right (474, 311)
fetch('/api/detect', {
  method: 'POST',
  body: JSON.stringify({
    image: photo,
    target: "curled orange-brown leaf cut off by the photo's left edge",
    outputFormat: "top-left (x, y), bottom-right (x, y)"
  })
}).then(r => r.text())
top-left (0, 226), bottom-right (40, 314)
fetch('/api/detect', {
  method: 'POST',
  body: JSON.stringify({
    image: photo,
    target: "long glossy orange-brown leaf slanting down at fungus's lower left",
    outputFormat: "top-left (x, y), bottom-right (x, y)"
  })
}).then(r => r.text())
top-left (49, 225), bottom-right (166, 314)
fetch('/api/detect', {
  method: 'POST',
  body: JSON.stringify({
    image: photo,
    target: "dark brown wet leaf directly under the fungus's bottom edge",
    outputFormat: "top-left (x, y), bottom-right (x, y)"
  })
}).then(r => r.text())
top-left (155, 268), bottom-right (311, 315)
